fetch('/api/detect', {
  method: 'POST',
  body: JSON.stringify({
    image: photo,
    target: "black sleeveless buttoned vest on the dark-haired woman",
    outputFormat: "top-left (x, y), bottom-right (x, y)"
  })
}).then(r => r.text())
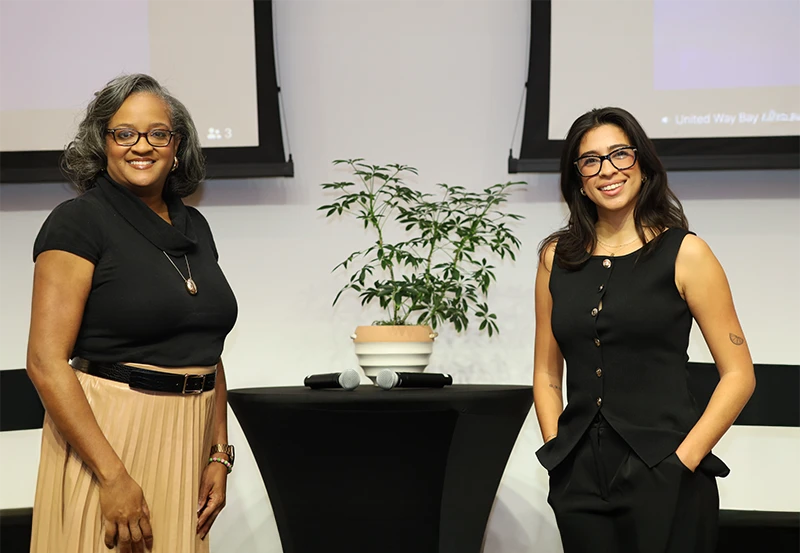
top-left (537, 228), bottom-right (727, 475)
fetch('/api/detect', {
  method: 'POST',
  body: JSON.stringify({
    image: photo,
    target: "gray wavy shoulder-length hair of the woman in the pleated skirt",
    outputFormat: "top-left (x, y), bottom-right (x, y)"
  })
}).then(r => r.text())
top-left (61, 74), bottom-right (206, 198)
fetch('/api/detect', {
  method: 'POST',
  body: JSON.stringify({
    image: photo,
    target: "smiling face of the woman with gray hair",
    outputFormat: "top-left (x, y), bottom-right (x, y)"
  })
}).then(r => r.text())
top-left (106, 92), bottom-right (180, 194)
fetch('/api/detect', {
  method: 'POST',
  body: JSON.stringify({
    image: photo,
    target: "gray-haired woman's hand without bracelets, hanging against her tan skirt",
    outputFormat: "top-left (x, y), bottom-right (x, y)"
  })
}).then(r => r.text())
top-left (100, 471), bottom-right (153, 553)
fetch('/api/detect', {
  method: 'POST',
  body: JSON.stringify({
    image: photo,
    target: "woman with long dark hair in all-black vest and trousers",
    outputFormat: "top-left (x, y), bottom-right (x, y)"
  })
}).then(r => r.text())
top-left (533, 108), bottom-right (755, 553)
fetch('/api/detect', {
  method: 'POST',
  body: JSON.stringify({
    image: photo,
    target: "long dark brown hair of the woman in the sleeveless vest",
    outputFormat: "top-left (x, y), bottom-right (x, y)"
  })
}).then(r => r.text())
top-left (539, 107), bottom-right (689, 270)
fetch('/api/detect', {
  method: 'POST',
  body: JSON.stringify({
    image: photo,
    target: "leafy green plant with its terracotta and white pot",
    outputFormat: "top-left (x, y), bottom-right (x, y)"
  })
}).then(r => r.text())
top-left (318, 159), bottom-right (524, 378)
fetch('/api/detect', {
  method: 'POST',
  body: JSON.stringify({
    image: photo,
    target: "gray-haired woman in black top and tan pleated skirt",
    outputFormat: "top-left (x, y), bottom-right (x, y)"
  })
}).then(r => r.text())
top-left (27, 75), bottom-right (237, 553)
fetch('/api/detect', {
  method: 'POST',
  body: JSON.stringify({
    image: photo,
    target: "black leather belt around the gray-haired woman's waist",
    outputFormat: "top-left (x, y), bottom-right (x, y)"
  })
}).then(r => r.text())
top-left (71, 358), bottom-right (217, 394)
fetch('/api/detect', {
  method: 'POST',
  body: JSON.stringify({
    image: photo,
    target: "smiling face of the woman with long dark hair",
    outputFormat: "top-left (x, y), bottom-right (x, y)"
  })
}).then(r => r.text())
top-left (578, 125), bottom-right (642, 215)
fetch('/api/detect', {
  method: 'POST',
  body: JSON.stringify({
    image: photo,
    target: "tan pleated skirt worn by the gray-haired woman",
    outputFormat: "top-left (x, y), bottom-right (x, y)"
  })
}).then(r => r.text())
top-left (31, 371), bottom-right (214, 553)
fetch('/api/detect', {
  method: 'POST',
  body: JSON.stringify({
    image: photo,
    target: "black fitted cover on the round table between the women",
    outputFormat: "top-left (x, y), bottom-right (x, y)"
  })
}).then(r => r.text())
top-left (228, 385), bottom-right (535, 553)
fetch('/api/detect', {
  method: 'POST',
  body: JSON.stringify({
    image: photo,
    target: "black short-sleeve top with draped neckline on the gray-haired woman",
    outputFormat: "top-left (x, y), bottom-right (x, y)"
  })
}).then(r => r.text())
top-left (33, 173), bottom-right (237, 367)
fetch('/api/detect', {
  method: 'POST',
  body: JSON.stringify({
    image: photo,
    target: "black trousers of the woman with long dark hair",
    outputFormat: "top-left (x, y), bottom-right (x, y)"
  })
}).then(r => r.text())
top-left (547, 416), bottom-right (719, 553)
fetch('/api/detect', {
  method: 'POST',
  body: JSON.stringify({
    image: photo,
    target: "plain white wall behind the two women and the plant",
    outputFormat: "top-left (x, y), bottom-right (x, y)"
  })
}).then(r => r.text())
top-left (0, 0), bottom-right (800, 553)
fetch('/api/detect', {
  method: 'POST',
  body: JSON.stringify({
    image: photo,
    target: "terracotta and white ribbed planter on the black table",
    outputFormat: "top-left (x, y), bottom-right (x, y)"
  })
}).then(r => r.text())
top-left (351, 325), bottom-right (437, 380)
